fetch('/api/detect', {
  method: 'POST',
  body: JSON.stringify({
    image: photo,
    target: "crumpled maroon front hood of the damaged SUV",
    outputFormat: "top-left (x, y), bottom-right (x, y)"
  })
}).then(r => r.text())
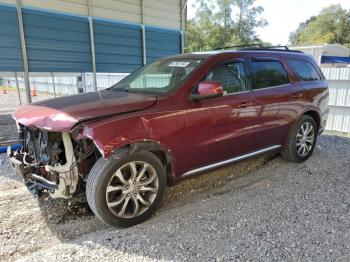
top-left (13, 90), bottom-right (157, 132)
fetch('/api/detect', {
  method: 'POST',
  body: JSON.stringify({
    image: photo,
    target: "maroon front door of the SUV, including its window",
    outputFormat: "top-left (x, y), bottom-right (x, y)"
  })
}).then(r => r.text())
top-left (186, 59), bottom-right (254, 171)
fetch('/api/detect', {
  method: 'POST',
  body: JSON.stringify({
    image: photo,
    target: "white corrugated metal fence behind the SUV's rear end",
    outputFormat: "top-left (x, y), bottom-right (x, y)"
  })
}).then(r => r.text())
top-left (322, 68), bottom-right (350, 133)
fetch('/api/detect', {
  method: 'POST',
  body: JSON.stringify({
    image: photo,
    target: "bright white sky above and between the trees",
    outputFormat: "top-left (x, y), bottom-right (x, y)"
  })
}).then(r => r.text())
top-left (187, 0), bottom-right (350, 45)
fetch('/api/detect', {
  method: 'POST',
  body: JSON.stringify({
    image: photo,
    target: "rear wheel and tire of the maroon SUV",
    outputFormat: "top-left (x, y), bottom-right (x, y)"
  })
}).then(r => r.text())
top-left (281, 115), bottom-right (318, 163)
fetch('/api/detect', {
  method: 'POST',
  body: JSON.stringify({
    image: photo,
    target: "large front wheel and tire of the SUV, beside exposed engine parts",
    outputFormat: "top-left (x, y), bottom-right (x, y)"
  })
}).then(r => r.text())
top-left (86, 152), bottom-right (166, 227)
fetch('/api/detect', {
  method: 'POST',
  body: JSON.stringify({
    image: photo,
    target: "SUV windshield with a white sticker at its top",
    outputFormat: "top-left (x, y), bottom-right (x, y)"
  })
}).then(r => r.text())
top-left (112, 59), bottom-right (201, 94)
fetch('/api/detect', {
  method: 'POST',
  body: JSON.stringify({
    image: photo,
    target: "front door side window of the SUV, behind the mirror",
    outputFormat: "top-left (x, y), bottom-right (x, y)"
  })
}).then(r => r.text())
top-left (204, 61), bottom-right (246, 95)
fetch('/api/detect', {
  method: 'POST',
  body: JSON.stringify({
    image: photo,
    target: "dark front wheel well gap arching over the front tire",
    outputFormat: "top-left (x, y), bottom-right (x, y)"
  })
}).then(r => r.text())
top-left (111, 141), bottom-right (173, 183)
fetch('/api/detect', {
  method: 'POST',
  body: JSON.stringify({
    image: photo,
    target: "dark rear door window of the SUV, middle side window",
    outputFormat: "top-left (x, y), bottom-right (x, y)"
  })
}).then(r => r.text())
top-left (252, 60), bottom-right (289, 89)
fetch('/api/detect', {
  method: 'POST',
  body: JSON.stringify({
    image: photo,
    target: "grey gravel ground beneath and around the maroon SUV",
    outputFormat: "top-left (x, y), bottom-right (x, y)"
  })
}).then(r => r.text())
top-left (0, 112), bottom-right (350, 261)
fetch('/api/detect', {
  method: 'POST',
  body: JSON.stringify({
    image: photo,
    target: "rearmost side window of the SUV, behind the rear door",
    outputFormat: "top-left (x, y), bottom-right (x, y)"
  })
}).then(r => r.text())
top-left (287, 59), bottom-right (321, 81)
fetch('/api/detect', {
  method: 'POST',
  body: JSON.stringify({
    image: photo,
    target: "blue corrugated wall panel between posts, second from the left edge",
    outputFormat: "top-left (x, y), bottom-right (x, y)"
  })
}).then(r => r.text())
top-left (22, 8), bottom-right (91, 72)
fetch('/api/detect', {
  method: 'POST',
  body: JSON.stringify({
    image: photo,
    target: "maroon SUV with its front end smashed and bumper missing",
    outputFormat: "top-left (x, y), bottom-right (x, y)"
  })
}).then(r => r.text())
top-left (8, 49), bottom-right (328, 226)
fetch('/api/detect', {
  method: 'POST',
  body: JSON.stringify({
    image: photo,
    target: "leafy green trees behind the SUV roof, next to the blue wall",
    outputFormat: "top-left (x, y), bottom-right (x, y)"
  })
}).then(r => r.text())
top-left (185, 0), bottom-right (267, 52)
